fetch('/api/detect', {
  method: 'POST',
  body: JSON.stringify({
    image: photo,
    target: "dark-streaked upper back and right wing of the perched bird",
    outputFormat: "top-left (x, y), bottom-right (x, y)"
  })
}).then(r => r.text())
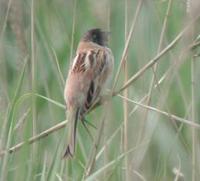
top-left (67, 47), bottom-right (113, 114)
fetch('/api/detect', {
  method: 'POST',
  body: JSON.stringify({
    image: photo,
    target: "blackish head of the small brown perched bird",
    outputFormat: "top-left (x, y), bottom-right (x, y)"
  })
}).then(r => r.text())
top-left (83, 28), bottom-right (109, 46)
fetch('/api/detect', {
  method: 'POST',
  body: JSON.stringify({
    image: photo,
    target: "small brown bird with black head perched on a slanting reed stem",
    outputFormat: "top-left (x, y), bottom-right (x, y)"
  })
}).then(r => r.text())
top-left (64, 29), bottom-right (114, 158)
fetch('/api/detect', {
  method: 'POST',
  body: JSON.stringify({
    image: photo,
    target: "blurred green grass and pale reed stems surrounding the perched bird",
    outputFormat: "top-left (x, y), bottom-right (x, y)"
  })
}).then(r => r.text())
top-left (0, 0), bottom-right (200, 181)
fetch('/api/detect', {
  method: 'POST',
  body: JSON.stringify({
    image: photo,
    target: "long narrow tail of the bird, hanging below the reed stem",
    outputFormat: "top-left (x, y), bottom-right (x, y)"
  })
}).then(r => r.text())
top-left (63, 108), bottom-right (80, 158)
